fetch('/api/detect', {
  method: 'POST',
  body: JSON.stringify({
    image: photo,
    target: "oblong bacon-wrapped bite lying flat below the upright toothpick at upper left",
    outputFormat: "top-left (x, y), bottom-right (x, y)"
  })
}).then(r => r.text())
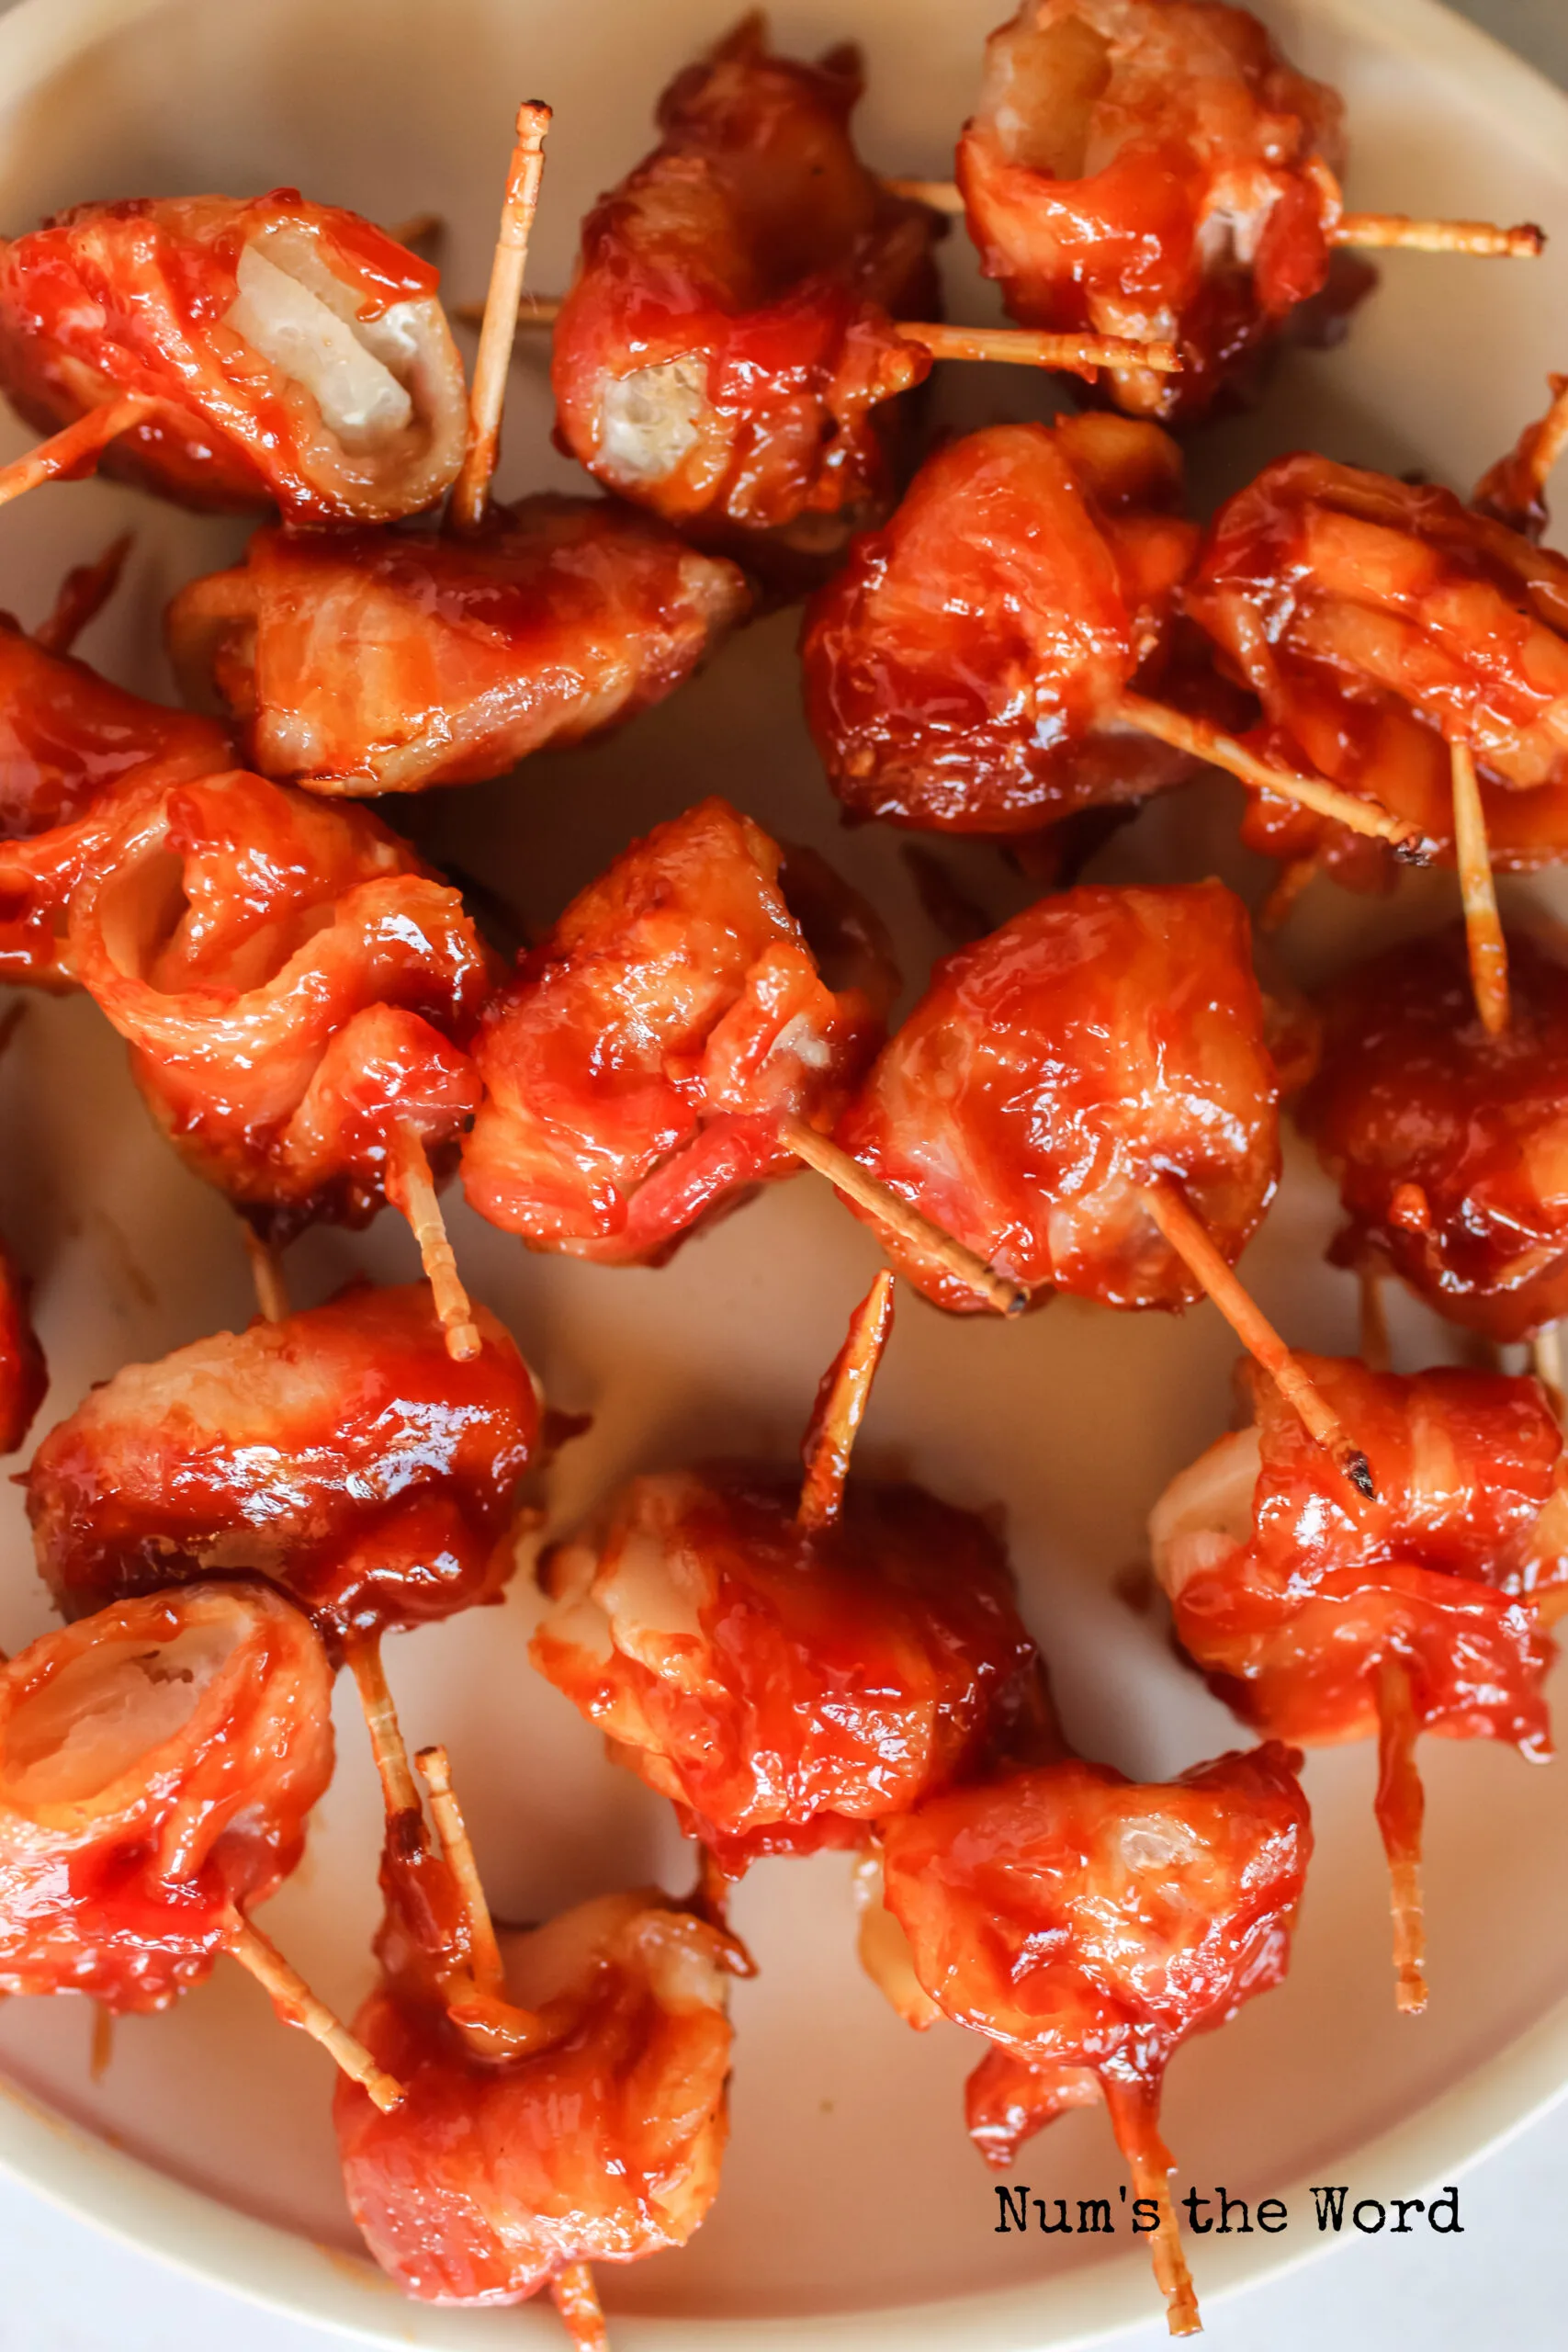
top-left (167, 494), bottom-right (750, 795)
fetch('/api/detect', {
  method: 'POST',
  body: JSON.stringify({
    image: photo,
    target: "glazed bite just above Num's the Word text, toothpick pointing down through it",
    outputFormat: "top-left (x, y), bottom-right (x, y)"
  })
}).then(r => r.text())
top-left (863, 1740), bottom-right (1312, 2335)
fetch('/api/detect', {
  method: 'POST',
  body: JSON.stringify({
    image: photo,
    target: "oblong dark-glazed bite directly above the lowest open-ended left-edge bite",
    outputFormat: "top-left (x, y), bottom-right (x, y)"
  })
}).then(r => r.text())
top-left (28, 1284), bottom-right (538, 1637)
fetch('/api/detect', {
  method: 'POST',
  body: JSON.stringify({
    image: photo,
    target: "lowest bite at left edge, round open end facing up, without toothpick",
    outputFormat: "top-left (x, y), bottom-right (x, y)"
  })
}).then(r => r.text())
top-left (0, 1583), bottom-right (332, 2011)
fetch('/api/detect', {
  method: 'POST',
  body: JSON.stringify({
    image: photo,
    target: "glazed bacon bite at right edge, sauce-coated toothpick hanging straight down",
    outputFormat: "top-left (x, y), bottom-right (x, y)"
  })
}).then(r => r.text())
top-left (1149, 1357), bottom-right (1568, 2008)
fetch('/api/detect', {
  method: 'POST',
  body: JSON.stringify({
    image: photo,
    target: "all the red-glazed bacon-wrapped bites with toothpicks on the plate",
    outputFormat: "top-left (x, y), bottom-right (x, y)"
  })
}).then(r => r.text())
top-left (0, 0), bottom-right (1568, 2347)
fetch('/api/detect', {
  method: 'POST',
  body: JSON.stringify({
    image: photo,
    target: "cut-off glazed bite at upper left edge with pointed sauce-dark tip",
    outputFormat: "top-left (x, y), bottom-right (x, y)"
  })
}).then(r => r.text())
top-left (0, 614), bottom-right (232, 988)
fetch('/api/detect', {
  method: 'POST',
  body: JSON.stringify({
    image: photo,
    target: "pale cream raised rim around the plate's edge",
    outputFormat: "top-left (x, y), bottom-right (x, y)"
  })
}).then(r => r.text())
top-left (0, 0), bottom-right (1568, 2352)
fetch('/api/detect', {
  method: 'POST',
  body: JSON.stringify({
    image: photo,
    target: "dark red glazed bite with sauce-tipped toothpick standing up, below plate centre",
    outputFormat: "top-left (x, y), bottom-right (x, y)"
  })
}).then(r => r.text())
top-left (531, 1272), bottom-right (1048, 1877)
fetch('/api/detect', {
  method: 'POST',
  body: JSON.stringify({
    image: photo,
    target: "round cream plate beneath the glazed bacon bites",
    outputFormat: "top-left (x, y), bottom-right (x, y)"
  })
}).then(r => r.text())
top-left (0, 0), bottom-right (1568, 2352)
